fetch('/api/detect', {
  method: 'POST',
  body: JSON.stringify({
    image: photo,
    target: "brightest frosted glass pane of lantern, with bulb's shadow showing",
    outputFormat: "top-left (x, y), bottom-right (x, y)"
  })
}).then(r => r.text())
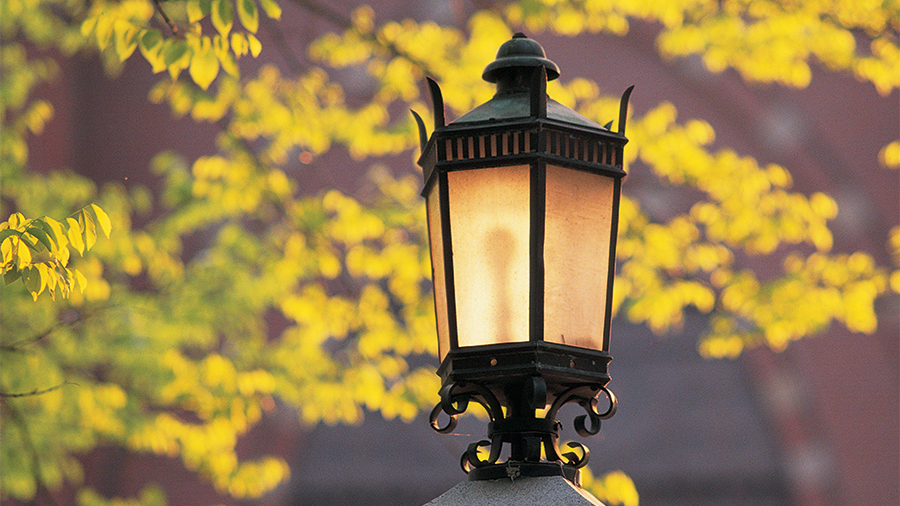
top-left (448, 165), bottom-right (530, 346)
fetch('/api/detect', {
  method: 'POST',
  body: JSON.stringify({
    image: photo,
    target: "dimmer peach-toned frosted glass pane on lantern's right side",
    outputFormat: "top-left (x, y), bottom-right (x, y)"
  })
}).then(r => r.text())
top-left (544, 166), bottom-right (615, 350)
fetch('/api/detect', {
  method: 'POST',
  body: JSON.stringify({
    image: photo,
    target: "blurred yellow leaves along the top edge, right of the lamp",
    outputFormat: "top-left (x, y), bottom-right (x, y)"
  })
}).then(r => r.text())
top-left (505, 0), bottom-right (900, 95)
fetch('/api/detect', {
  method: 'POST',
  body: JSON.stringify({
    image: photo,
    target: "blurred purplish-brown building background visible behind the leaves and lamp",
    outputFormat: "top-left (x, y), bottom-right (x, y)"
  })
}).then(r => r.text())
top-left (14, 0), bottom-right (900, 506)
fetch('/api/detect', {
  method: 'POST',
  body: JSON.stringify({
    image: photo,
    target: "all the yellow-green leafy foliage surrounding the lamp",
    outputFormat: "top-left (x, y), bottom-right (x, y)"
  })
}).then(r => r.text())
top-left (0, 0), bottom-right (900, 506)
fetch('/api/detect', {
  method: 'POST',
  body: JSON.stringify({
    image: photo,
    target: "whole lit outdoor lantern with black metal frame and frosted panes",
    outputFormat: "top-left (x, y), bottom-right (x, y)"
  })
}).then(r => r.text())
top-left (413, 33), bottom-right (632, 483)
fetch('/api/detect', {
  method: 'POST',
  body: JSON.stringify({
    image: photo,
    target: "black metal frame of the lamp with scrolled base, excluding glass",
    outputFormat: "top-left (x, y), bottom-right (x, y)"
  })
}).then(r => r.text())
top-left (413, 34), bottom-right (633, 482)
